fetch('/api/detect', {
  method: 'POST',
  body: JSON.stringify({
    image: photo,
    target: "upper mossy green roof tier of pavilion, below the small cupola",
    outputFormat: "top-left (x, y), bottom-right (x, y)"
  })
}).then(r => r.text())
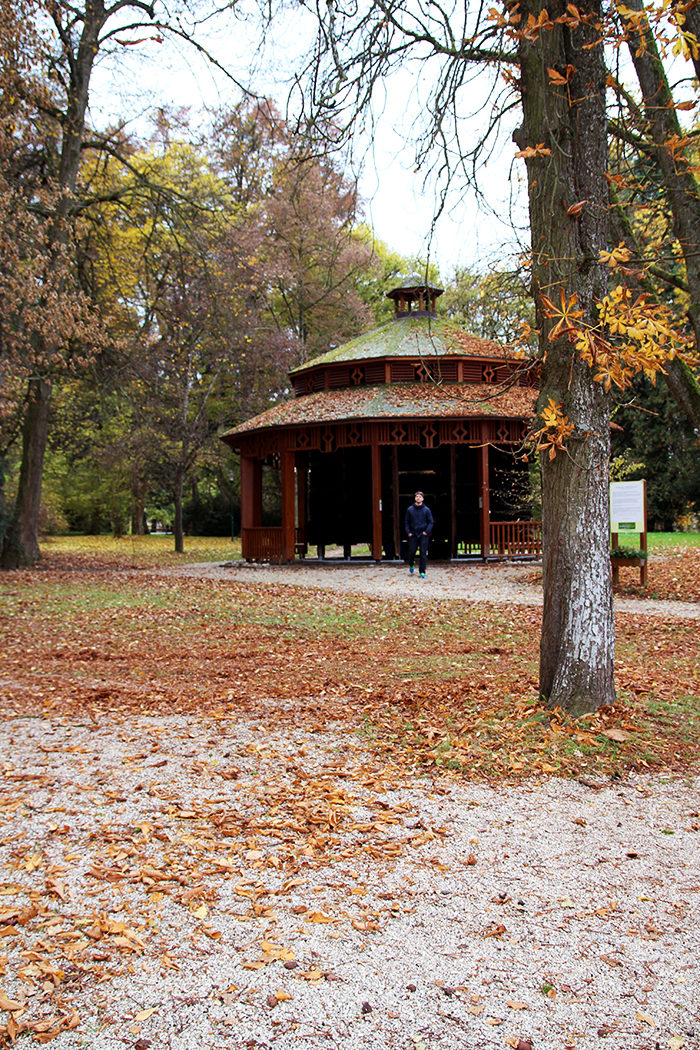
top-left (290, 314), bottom-right (516, 375)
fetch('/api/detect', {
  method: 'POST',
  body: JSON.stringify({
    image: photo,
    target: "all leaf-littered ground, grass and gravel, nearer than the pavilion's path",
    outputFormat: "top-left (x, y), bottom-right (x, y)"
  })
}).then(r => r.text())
top-left (0, 564), bottom-right (700, 1050)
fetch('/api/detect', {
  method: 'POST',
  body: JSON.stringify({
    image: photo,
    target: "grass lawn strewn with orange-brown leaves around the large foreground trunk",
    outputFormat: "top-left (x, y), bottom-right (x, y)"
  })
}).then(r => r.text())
top-left (0, 534), bottom-right (700, 778)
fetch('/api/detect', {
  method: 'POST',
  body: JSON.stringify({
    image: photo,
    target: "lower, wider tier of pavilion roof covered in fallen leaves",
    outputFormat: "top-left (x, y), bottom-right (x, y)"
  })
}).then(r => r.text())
top-left (224, 382), bottom-right (537, 440)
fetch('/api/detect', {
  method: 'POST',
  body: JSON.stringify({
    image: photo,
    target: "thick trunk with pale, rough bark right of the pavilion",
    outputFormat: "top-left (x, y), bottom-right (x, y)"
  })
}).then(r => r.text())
top-left (516, 0), bottom-right (615, 716)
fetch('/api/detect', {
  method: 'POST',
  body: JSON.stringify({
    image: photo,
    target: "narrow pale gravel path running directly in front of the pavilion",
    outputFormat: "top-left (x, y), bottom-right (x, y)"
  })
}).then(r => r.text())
top-left (171, 562), bottom-right (700, 620)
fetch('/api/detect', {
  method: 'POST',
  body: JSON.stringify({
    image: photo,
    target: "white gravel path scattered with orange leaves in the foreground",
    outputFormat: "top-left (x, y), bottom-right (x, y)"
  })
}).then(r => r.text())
top-left (0, 702), bottom-right (700, 1050)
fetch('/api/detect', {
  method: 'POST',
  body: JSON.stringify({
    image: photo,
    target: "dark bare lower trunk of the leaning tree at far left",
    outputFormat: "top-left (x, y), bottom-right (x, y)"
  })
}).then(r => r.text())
top-left (1, 377), bottom-right (51, 569)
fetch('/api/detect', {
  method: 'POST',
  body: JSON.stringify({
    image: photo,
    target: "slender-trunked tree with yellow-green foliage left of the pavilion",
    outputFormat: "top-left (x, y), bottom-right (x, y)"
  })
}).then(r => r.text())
top-left (85, 141), bottom-right (264, 551)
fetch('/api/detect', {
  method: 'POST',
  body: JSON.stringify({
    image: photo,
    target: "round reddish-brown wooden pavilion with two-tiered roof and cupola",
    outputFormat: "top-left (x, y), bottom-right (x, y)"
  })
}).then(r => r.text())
top-left (222, 279), bottom-right (542, 563)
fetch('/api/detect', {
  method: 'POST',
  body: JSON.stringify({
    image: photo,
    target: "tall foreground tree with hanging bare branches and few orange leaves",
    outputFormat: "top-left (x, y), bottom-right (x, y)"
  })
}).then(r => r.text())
top-left (259, 0), bottom-right (688, 715)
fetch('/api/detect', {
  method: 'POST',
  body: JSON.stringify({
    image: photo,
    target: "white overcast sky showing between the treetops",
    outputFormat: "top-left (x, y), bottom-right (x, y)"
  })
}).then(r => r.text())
top-left (90, 5), bottom-right (527, 277)
